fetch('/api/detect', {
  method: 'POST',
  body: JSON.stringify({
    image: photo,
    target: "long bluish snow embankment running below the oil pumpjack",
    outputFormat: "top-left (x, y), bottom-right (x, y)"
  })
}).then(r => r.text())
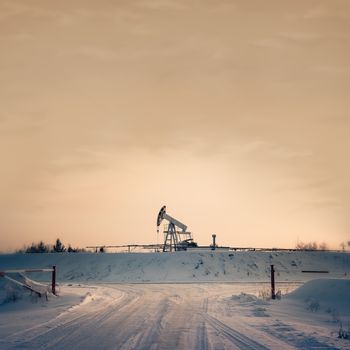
top-left (0, 251), bottom-right (350, 283)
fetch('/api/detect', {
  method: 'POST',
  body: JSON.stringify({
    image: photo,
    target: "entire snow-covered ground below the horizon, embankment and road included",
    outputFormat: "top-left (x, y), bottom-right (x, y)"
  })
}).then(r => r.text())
top-left (0, 252), bottom-right (350, 349)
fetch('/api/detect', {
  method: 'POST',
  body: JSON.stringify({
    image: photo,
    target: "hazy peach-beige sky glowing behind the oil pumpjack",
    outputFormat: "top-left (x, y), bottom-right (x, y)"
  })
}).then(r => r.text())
top-left (0, 0), bottom-right (350, 250)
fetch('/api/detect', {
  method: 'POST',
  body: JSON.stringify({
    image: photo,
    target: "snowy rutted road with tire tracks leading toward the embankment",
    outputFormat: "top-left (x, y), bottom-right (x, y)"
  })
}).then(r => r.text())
top-left (0, 284), bottom-right (348, 350)
